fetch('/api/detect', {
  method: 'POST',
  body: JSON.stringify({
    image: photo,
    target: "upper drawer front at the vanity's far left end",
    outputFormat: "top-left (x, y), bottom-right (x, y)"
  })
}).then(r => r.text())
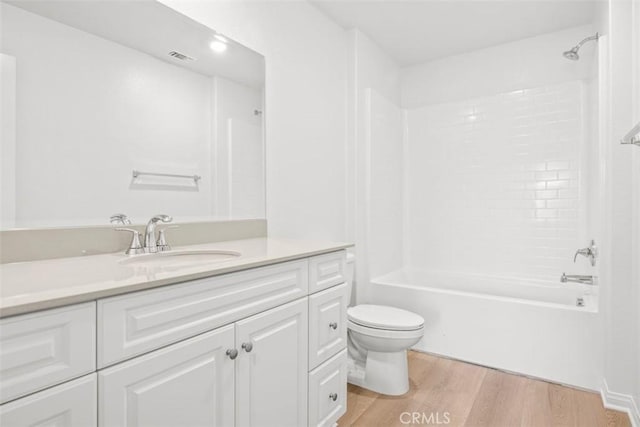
top-left (0, 302), bottom-right (96, 403)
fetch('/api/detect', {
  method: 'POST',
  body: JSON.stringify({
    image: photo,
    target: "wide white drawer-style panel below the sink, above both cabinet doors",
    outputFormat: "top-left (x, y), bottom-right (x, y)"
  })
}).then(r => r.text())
top-left (98, 260), bottom-right (308, 368)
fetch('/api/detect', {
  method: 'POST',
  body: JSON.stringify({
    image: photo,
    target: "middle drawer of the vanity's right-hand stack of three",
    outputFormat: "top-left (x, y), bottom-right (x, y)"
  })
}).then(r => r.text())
top-left (309, 283), bottom-right (349, 368)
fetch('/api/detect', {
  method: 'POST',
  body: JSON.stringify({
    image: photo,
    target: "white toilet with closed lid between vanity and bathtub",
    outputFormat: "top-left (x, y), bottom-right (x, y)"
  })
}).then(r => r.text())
top-left (346, 254), bottom-right (424, 396)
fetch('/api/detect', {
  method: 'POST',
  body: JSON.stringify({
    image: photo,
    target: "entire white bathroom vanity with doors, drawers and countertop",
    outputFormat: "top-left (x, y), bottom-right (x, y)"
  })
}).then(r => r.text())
top-left (0, 244), bottom-right (350, 427)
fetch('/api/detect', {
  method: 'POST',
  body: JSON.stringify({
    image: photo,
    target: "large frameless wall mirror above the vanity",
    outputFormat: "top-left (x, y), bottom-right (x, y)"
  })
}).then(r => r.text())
top-left (0, 0), bottom-right (265, 229)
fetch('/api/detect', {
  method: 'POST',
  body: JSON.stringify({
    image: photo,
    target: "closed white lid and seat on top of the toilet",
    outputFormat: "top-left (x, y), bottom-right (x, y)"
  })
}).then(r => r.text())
top-left (347, 304), bottom-right (424, 331)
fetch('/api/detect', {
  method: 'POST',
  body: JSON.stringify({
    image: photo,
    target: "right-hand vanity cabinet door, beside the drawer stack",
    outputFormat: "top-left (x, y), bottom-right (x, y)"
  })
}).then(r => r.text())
top-left (236, 298), bottom-right (308, 427)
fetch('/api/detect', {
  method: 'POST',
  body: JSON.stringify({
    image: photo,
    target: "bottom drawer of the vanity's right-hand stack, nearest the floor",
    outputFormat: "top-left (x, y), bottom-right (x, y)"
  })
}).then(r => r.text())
top-left (309, 349), bottom-right (347, 426)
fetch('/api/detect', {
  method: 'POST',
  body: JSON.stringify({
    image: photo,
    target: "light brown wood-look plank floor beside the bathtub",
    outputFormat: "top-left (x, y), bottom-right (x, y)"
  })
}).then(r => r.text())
top-left (338, 351), bottom-right (631, 427)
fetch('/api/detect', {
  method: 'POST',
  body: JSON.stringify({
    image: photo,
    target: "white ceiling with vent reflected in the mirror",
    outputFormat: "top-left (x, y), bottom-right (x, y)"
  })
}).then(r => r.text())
top-left (3, 0), bottom-right (264, 88)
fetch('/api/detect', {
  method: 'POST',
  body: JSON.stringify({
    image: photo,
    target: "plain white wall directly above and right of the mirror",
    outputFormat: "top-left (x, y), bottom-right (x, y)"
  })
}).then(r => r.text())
top-left (163, 0), bottom-right (347, 240)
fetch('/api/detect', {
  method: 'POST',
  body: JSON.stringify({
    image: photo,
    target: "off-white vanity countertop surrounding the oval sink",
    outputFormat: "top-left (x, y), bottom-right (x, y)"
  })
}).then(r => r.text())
top-left (0, 238), bottom-right (352, 317)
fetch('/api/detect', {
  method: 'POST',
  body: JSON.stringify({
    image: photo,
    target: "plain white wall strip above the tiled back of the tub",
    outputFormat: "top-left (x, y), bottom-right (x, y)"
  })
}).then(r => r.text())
top-left (401, 25), bottom-right (596, 108)
